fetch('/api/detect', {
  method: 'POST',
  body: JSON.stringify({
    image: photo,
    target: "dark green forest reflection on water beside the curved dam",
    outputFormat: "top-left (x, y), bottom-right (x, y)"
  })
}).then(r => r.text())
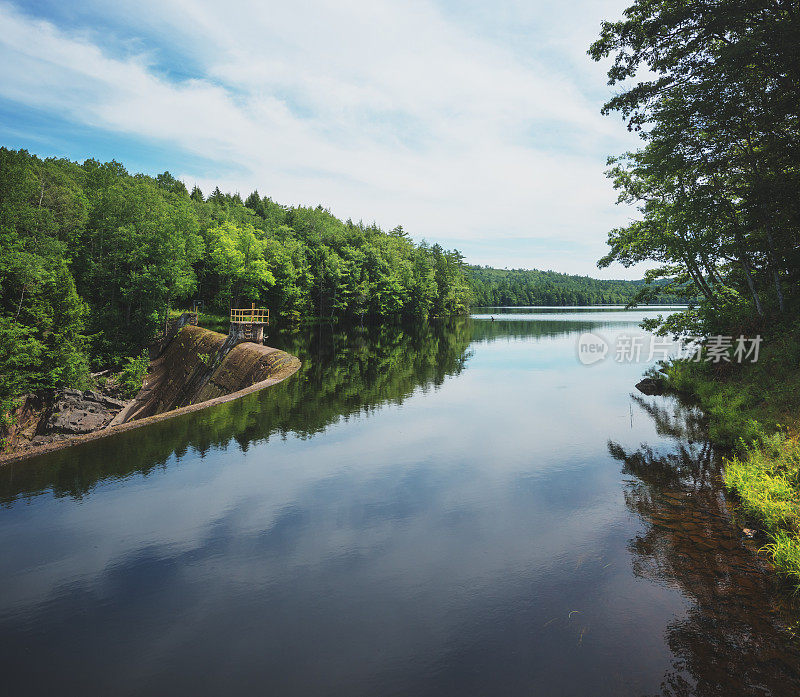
top-left (0, 318), bottom-right (472, 502)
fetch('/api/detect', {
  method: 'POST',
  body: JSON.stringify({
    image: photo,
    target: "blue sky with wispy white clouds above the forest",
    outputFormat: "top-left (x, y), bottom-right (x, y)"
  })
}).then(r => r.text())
top-left (0, 0), bottom-right (643, 278)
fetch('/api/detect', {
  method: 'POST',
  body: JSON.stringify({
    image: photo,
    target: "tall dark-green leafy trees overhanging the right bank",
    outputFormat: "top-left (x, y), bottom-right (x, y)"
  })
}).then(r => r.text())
top-left (589, 0), bottom-right (800, 334)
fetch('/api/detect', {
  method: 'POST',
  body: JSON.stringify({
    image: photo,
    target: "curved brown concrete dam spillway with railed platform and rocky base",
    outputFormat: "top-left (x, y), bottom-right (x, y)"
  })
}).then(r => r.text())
top-left (0, 313), bottom-right (300, 465)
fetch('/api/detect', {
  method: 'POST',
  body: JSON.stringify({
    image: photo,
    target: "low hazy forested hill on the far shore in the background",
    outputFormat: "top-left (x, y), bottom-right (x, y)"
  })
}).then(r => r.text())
top-left (467, 266), bottom-right (681, 306)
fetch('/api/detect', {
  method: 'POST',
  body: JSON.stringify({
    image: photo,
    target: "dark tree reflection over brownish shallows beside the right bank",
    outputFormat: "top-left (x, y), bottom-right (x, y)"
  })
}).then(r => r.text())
top-left (608, 396), bottom-right (800, 697)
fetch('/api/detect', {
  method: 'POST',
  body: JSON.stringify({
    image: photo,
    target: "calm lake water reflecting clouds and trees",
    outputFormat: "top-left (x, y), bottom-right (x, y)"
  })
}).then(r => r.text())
top-left (0, 308), bottom-right (800, 697)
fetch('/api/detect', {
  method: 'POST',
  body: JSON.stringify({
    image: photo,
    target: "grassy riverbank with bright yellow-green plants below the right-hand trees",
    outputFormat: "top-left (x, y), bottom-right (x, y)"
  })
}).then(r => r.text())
top-left (664, 327), bottom-right (800, 587)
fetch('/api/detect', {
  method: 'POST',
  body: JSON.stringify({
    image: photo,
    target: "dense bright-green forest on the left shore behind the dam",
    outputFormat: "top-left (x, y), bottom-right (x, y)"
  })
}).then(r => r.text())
top-left (0, 148), bottom-right (471, 400)
